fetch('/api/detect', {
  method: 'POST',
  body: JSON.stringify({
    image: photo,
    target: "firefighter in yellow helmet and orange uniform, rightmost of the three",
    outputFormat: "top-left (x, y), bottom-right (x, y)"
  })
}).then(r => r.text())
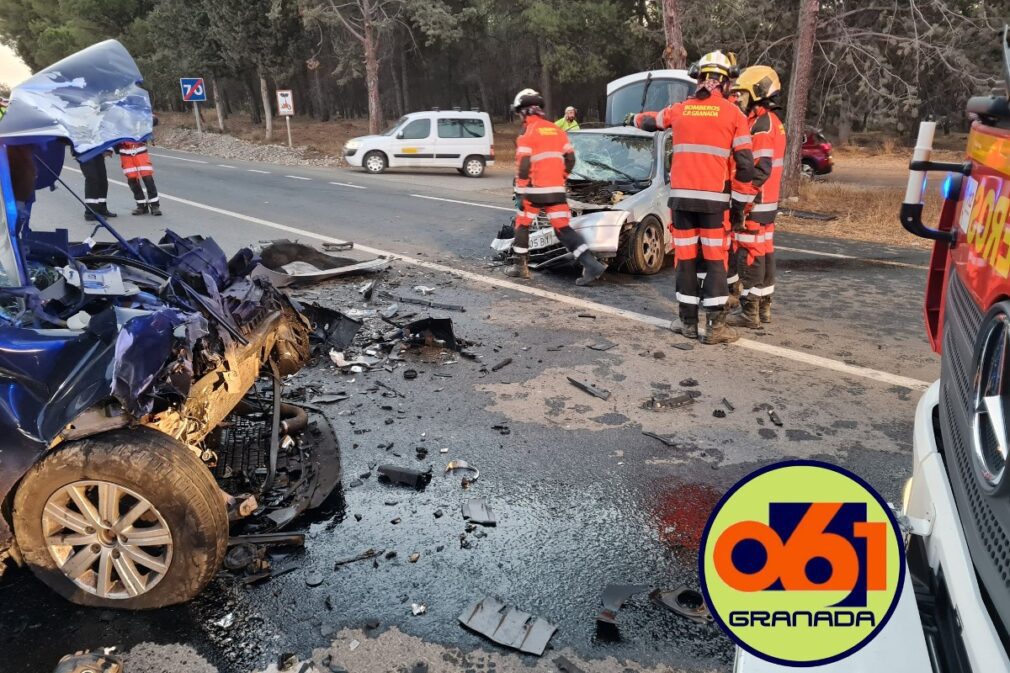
top-left (728, 66), bottom-right (786, 329)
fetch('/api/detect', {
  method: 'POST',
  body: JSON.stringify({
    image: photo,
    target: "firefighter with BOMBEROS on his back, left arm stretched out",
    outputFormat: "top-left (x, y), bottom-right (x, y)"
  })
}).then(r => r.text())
top-left (625, 52), bottom-right (754, 345)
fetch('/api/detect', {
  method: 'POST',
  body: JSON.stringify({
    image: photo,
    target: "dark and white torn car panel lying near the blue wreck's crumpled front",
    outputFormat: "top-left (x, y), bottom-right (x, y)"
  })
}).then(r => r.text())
top-left (253, 239), bottom-right (389, 288)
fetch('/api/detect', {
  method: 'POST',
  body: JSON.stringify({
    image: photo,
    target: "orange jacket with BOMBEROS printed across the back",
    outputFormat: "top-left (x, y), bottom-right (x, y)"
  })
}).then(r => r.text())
top-left (635, 91), bottom-right (753, 212)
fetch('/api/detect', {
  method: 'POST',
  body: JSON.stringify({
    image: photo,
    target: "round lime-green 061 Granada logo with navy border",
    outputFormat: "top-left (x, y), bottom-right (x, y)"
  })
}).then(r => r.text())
top-left (699, 461), bottom-right (905, 666)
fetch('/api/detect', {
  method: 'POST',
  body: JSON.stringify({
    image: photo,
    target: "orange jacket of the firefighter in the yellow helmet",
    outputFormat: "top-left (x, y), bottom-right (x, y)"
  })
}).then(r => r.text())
top-left (733, 107), bottom-right (786, 224)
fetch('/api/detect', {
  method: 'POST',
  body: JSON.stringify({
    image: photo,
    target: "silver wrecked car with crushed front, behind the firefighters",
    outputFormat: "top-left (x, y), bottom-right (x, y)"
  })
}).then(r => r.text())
top-left (491, 126), bottom-right (673, 275)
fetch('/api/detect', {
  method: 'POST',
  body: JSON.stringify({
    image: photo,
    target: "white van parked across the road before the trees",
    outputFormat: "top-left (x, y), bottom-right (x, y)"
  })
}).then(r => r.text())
top-left (343, 109), bottom-right (495, 178)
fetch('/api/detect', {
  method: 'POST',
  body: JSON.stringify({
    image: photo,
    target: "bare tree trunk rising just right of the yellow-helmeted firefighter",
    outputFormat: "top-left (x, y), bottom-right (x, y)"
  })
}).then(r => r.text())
top-left (782, 0), bottom-right (820, 197)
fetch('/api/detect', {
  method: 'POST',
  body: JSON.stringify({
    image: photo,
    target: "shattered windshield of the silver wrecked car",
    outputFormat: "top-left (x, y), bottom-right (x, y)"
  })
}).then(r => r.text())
top-left (569, 132), bottom-right (655, 182)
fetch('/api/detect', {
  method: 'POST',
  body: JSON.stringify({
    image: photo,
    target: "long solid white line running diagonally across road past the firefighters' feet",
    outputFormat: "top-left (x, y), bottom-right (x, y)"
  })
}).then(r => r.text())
top-left (68, 167), bottom-right (930, 390)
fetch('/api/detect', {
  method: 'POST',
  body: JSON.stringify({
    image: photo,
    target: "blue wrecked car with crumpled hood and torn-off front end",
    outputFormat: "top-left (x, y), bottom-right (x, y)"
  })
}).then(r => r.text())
top-left (0, 40), bottom-right (339, 608)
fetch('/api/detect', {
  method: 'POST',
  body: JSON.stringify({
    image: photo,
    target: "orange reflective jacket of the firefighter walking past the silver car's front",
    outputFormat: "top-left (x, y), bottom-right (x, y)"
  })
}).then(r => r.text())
top-left (515, 115), bottom-right (575, 205)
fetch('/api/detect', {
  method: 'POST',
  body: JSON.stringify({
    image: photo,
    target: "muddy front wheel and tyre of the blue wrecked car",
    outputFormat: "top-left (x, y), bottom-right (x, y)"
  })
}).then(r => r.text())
top-left (12, 427), bottom-right (228, 609)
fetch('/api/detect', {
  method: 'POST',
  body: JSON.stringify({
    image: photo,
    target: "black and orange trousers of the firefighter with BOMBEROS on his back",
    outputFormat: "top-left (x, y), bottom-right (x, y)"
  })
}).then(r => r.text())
top-left (673, 210), bottom-right (729, 322)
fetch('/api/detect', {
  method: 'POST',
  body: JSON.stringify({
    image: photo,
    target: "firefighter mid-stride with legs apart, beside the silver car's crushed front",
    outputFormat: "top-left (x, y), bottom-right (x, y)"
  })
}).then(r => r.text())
top-left (505, 89), bottom-right (607, 285)
